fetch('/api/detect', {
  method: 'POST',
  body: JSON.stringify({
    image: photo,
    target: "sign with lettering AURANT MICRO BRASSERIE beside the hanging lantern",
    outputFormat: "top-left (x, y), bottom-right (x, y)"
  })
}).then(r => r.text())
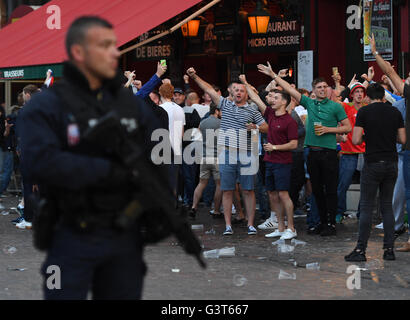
top-left (247, 18), bottom-right (300, 53)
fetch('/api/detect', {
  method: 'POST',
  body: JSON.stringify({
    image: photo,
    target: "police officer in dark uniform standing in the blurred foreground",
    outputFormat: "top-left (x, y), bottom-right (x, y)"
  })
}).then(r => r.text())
top-left (18, 16), bottom-right (159, 300)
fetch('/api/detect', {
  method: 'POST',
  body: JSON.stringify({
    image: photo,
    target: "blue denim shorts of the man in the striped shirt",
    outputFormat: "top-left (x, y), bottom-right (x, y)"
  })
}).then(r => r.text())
top-left (218, 148), bottom-right (259, 191)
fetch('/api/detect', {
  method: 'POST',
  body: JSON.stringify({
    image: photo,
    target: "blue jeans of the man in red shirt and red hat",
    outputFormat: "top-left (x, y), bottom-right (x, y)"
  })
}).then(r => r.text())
top-left (337, 154), bottom-right (359, 214)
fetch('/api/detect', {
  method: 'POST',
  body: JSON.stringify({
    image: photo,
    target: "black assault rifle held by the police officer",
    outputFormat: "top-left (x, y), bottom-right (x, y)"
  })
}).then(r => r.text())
top-left (83, 111), bottom-right (206, 268)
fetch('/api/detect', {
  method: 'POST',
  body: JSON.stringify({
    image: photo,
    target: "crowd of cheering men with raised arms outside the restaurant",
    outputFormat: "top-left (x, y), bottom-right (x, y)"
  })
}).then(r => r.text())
top-left (113, 33), bottom-right (410, 261)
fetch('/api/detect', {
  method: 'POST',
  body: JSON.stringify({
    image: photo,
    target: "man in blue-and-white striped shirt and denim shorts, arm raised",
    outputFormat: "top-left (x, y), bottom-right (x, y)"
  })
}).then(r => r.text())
top-left (187, 68), bottom-right (268, 235)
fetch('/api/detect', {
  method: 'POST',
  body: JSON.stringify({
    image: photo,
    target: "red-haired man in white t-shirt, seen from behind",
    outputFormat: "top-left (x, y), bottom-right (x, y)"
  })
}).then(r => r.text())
top-left (159, 83), bottom-right (185, 195)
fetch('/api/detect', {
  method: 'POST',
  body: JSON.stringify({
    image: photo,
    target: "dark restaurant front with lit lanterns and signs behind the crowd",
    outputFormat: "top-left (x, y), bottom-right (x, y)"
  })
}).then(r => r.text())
top-left (123, 0), bottom-right (410, 94)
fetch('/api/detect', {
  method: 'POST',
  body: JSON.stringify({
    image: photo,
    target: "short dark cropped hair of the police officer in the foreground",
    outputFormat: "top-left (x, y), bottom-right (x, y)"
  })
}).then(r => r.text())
top-left (65, 16), bottom-right (113, 59)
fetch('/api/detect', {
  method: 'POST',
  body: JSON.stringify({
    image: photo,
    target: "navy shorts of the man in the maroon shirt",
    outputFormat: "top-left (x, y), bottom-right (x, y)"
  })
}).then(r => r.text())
top-left (265, 162), bottom-right (292, 191)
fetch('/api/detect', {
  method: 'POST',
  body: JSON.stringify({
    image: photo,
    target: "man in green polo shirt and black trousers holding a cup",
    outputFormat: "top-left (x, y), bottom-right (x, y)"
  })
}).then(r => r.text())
top-left (258, 62), bottom-right (352, 236)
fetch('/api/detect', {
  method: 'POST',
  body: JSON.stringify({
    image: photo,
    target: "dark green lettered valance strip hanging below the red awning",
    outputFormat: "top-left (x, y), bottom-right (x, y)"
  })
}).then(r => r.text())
top-left (0, 63), bottom-right (63, 80)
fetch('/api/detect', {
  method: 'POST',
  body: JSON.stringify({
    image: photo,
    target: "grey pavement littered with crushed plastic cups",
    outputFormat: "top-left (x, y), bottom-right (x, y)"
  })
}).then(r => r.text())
top-left (0, 197), bottom-right (410, 300)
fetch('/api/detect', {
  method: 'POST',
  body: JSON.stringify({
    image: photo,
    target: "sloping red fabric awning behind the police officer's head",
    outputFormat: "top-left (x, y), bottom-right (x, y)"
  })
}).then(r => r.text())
top-left (0, 0), bottom-right (201, 68)
